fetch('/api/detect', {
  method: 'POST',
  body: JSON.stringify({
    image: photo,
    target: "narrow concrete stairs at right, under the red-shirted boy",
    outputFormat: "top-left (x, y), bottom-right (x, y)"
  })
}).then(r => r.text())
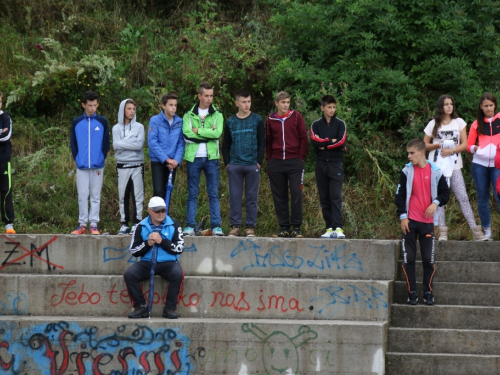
top-left (386, 241), bottom-right (500, 375)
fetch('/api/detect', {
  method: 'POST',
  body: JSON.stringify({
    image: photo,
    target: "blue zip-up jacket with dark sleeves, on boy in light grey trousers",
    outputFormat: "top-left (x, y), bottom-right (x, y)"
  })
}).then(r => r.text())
top-left (70, 112), bottom-right (109, 169)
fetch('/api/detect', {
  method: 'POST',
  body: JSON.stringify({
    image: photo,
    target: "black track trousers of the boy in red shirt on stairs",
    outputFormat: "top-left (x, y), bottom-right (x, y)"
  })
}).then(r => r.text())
top-left (401, 220), bottom-right (436, 293)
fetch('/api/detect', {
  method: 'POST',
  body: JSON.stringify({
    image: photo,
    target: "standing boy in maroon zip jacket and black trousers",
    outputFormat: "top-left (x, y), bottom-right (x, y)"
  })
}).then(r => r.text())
top-left (266, 91), bottom-right (307, 238)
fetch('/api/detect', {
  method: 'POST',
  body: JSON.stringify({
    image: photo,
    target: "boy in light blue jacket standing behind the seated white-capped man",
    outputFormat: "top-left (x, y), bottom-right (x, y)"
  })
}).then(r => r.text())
top-left (148, 93), bottom-right (184, 207)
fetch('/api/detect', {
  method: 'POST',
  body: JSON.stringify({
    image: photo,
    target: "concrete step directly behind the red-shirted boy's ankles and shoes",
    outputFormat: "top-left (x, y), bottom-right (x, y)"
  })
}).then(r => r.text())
top-left (394, 281), bottom-right (500, 306)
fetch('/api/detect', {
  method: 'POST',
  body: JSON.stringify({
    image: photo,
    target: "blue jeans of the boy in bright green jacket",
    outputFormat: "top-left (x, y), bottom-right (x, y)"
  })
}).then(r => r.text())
top-left (186, 158), bottom-right (221, 228)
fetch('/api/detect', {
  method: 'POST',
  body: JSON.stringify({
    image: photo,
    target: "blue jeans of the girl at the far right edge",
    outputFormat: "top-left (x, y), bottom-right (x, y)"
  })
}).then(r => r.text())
top-left (472, 163), bottom-right (500, 228)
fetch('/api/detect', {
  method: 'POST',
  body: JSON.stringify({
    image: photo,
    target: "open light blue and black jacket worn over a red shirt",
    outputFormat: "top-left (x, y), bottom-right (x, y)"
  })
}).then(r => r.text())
top-left (395, 160), bottom-right (450, 226)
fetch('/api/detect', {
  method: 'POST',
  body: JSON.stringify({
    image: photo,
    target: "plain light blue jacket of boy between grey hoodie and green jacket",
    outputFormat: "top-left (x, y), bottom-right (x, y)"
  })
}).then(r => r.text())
top-left (148, 112), bottom-right (184, 165)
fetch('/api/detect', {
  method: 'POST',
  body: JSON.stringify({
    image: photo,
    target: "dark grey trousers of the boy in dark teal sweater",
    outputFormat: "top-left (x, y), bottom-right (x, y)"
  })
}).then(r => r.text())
top-left (227, 164), bottom-right (260, 228)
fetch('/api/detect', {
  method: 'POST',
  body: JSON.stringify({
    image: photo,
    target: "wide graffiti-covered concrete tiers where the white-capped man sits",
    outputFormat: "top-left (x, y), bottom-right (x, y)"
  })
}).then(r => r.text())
top-left (0, 235), bottom-right (398, 375)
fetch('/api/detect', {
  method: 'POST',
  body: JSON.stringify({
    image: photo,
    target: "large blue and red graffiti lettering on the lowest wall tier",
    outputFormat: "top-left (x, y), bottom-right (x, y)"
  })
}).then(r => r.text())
top-left (0, 321), bottom-right (192, 375)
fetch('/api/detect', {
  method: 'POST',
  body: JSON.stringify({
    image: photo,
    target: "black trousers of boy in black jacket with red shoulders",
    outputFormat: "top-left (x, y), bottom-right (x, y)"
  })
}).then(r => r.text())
top-left (316, 160), bottom-right (344, 229)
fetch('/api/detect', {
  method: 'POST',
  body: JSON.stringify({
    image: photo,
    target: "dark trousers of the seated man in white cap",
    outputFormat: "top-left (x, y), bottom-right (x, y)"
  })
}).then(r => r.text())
top-left (123, 260), bottom-right (183, 310)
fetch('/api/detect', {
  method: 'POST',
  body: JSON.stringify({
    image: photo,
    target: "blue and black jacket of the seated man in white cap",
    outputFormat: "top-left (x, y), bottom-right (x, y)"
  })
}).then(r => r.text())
top-left (130, 215), bottom-right (184, 263)
